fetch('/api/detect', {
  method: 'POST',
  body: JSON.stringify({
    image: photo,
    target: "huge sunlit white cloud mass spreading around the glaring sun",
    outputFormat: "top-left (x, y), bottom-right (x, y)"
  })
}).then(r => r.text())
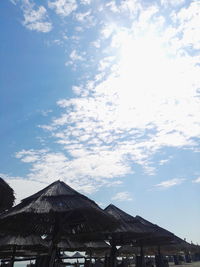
top-left (5, 0), bottom-right (200, 197)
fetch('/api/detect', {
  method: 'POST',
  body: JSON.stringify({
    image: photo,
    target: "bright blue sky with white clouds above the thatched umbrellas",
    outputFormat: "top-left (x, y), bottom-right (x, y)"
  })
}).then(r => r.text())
top-left (0, 0), bottom-right (200, 244)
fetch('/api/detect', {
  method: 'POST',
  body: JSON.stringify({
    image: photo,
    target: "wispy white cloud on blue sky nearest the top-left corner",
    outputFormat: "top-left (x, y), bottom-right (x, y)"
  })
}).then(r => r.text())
top-left (23, 1), bottom-right (52, 32)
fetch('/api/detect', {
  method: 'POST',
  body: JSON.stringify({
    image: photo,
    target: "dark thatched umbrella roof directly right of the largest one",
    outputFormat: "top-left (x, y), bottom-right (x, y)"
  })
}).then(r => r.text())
top-left (105, 204), bottom-right (151, 245)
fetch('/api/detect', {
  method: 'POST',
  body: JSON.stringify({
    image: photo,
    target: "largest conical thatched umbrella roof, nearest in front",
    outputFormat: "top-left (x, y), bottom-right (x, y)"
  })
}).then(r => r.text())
top-left (0, 181), bottom-right (116, 235)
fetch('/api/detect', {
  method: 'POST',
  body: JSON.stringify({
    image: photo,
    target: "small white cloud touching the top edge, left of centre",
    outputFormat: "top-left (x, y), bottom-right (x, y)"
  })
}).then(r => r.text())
top-left (48, 0), bottom-right (78, 17)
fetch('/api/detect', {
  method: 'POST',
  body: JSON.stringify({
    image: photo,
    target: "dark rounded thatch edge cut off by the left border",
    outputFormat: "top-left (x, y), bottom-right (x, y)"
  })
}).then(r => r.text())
top-left (0, 178), bottom-right (15, 213)
